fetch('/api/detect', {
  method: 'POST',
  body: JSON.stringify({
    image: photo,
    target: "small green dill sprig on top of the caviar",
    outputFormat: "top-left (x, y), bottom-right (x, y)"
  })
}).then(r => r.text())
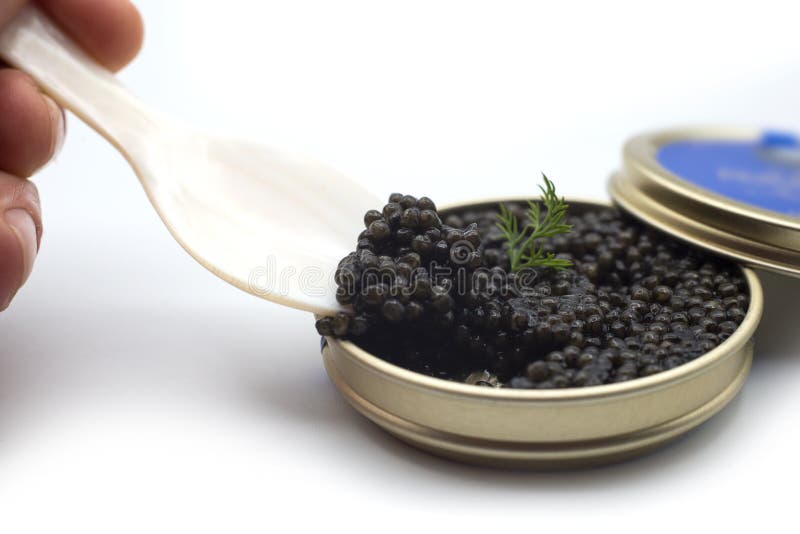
top-left (497, 174), bottom-right (572, 272)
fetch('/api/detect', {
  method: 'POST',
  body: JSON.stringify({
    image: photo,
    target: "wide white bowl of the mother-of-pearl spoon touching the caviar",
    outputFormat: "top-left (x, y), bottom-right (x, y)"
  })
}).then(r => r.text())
top-left (133, 128), bottom-right (377, 314)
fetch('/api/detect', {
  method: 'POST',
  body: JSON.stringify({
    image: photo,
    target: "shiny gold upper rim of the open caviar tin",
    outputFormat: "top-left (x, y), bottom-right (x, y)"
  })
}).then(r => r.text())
top-left (326, 198), bottom-right (764, 402)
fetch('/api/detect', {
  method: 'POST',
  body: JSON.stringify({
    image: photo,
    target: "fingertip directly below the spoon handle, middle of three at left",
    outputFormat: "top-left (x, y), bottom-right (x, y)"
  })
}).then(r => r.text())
top-left (0, 69), bottom-right (65, 176)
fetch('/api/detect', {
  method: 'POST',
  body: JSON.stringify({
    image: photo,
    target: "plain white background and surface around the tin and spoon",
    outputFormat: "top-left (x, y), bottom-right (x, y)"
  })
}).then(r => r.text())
top-left (0, 0), bottom-right (800, 533)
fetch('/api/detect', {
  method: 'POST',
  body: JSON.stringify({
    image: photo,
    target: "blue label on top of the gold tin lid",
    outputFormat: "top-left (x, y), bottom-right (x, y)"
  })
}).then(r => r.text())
top-left (656, 132), bottom-right (800, 216)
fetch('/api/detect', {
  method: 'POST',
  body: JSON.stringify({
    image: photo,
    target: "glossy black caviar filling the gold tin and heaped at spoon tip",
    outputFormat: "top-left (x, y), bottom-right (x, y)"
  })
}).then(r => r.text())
top-left (317, 194), bottom-right (748, 388)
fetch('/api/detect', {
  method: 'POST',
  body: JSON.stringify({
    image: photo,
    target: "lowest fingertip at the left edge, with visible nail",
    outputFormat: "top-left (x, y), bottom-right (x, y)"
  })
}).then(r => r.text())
top-left (0, 171), bottom-right (42, 310)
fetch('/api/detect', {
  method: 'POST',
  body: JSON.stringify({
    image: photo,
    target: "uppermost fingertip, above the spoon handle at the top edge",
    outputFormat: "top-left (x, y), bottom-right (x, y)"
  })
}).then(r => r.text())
top-left (39, 0), bottom-right (144, 71)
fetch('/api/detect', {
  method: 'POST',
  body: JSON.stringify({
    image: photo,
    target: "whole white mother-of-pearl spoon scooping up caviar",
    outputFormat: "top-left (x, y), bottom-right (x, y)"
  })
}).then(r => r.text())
top-left (0, 5), bottom-right (378, 314)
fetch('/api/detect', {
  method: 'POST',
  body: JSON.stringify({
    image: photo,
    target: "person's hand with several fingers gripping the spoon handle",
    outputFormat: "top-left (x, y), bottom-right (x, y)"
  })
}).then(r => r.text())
top-left (0, 0), bottom-right (143, 311)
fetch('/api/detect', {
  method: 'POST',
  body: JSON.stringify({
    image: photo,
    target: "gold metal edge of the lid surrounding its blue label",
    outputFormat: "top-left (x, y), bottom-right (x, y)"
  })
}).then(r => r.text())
top-left (609, 128), bottom-right (800, 276)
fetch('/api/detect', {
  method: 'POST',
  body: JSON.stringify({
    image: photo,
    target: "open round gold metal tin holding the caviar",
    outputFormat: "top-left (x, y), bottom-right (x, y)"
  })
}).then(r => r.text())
top-left (322, 199), bottom-right (763, 469)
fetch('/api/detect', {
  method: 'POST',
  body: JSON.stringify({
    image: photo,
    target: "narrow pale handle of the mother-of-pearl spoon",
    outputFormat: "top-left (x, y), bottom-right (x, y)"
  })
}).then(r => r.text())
top-left (0, 4), bottom-right (160, 157)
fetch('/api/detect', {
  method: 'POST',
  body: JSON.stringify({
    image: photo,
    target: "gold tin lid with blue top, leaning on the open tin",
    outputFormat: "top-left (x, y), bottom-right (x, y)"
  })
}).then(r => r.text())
top-left (609, 128), bottom-right (800, 277)
